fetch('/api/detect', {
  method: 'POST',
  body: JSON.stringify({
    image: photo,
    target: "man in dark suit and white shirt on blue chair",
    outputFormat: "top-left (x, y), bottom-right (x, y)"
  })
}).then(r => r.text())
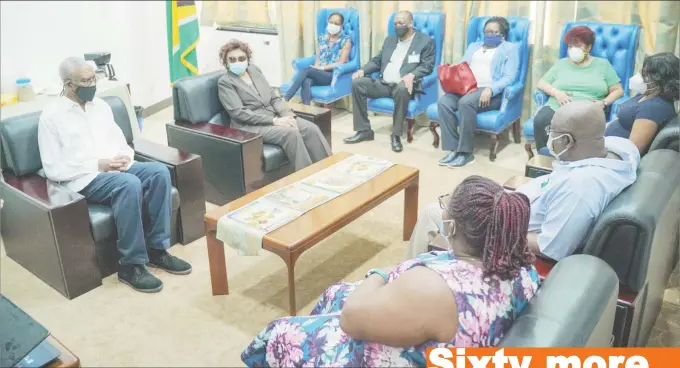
top-left (344, 11), bottom-right (435, 152)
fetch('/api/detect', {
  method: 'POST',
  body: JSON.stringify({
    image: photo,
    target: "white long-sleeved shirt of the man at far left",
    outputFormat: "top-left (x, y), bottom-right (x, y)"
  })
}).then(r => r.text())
top-left (38, 97), bottom-right (134, 192)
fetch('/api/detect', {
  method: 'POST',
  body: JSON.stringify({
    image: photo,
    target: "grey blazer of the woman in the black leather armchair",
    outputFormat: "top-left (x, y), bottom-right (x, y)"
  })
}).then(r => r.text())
top-left (217, 64), bottom-right (295, 125)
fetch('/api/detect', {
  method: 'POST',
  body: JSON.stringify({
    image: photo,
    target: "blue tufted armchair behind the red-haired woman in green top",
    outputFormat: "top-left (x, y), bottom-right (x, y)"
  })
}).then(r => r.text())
top-left (524, 22), bottom-right (640, 158)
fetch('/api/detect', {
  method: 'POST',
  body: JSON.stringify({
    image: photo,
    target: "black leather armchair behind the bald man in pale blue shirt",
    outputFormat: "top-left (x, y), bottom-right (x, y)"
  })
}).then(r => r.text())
top-left (537, 149), bottom-right (680, 347)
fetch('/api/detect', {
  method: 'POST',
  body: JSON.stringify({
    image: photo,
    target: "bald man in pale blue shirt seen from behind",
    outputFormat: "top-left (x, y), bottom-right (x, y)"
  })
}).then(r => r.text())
top-left (406, 101), bottom-right (640, 261)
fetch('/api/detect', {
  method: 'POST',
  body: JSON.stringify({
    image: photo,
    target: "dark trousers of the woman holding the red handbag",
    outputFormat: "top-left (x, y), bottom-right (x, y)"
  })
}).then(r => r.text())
top-left (437, 88), bottom-right (503, 153)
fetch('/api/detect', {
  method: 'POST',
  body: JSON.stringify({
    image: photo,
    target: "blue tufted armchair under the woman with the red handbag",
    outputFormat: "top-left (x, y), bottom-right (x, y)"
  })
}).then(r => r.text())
top-left (427, 17), bottom-right (531, 161)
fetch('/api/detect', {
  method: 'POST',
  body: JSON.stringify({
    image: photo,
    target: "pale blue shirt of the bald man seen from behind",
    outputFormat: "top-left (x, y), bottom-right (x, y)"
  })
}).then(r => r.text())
top-left (517, 137), bottom-right (640, 261)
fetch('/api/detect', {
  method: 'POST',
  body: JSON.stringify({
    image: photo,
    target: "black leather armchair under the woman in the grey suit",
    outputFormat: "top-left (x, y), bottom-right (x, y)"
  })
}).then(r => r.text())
top-left (166, 71), bottom-right (330, 205)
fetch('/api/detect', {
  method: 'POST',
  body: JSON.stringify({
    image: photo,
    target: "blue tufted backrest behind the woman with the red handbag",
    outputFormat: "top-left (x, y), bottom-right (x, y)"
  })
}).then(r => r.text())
top-left (465, 16), bottom-right (531, 84)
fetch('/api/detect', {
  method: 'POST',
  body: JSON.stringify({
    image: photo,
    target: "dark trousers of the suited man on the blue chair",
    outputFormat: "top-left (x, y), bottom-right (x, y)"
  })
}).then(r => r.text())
top-left (352, 77), bottom-right (411, 136)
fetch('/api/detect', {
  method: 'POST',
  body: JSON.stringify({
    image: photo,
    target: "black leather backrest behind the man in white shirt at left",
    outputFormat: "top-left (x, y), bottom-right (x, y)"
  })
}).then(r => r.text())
top-left (0, 96), bottom-right (133, 176)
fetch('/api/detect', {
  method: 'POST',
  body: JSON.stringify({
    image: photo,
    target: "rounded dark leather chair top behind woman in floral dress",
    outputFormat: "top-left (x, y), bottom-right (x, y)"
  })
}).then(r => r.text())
top-left (499, 254), bottom-right (618, 347)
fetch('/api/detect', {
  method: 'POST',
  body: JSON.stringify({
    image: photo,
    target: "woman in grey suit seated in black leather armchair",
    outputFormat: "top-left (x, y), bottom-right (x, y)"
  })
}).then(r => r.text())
top-left (217, 40), bottom-right (331, 171)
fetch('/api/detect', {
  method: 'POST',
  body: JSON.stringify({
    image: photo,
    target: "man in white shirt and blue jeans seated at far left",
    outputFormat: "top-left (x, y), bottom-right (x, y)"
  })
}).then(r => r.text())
top-left (38, 57), bottom-right (191, 293)
